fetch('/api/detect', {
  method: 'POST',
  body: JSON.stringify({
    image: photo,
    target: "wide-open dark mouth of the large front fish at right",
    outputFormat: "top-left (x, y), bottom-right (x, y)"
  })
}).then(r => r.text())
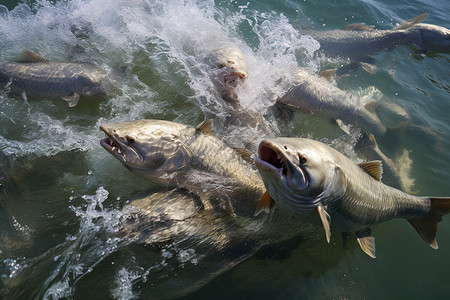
top-left (256, 142), bottom-right (288, 178)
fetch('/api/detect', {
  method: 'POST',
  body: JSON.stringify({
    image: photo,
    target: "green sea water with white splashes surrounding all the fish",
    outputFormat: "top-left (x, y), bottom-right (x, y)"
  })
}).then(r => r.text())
top-left (0, 0), bottom-right (450, 299)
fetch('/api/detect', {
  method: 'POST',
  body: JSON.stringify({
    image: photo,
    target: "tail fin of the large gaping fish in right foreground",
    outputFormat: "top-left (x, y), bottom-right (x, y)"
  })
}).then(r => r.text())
top-left (408, 197), bottom-right (450, 249)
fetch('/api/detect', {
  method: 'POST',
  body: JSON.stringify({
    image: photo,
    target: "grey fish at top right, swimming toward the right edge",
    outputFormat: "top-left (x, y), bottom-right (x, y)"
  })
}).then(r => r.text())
top-left (304, 13), bottom-right (450, 61)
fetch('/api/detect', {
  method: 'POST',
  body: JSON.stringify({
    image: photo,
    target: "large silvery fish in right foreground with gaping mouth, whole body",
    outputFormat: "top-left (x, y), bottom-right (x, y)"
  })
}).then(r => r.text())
top-left (256, 137), bottom-right (450, 258)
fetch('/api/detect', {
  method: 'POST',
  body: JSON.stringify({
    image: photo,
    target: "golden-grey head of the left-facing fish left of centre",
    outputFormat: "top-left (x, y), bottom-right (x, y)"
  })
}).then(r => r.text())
top-left (100, 120), bottom-right (194, 179)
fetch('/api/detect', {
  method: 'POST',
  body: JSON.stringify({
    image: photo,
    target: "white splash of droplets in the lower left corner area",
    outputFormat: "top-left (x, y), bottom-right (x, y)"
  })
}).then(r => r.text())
top-left (41, 187), bottom-right (128, 299)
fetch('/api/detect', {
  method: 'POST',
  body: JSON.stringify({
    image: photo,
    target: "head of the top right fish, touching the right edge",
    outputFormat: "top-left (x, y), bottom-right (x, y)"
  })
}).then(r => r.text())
top-left (413, 23), bottom-right (450, 53)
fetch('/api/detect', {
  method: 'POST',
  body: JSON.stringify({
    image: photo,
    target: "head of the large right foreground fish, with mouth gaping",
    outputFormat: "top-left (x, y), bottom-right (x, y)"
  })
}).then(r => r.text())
top-left (256, 138), bottom-right (338, 214)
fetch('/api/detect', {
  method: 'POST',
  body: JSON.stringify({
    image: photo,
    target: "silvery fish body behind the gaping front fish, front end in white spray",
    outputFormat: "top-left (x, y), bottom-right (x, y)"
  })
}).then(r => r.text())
top-left (276, 68), bottom-right (388, 138)
